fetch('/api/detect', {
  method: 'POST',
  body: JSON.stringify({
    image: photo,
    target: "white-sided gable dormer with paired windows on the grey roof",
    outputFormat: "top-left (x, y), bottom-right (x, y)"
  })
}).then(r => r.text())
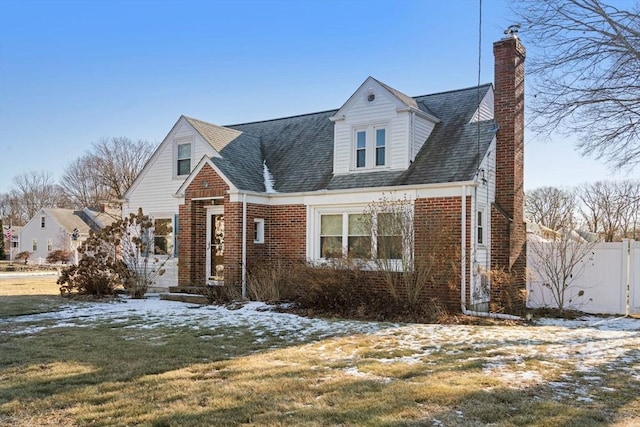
top-left (331, 77), bottom-right (439, 174)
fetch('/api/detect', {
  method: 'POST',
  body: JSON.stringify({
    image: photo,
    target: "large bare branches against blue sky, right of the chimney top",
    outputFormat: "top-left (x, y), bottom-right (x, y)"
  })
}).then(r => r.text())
top-left (512, 0), bottom-right (640, 168)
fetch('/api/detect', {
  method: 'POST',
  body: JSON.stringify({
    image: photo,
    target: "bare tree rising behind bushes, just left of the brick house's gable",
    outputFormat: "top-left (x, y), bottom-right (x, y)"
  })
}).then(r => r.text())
top-left (89, 137), bottom-right (155, 200)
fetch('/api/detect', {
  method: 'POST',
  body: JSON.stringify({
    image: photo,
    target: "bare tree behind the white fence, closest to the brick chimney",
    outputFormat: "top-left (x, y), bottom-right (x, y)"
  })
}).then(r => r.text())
top-left (524, 187), bottom-right (576, 230)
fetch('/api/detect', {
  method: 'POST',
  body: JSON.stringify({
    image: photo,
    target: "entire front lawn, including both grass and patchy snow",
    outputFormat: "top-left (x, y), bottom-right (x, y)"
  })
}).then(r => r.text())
top-left (0, 278), bottom-right (640, 426)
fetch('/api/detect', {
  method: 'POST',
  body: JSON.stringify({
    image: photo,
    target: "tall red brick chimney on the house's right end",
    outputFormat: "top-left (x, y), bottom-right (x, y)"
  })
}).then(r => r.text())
top-left (491, 30), bottom-right (526, 289)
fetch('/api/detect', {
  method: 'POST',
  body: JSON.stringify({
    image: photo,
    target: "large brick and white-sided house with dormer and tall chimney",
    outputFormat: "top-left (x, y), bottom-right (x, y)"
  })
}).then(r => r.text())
top-left (123, 32), bottom-right (526, 311)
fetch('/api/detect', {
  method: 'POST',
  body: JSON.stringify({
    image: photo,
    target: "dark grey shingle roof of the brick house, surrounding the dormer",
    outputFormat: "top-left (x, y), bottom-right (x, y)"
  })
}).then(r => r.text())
top-left (190, 83), bottom-right (496, 193)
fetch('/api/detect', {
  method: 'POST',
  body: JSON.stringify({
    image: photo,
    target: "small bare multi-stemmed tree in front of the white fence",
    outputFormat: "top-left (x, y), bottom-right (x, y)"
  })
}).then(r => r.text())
top-left (527, 235), bottom-right (594, 311)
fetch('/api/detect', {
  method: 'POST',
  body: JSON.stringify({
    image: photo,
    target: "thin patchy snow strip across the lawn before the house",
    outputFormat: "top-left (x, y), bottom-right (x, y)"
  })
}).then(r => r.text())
top-left (0, 295), bottom-right (640, 402)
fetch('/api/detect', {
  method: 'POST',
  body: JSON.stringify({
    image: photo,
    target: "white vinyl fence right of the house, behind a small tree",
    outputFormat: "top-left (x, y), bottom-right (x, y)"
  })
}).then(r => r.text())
top-left (527, 240), bottom-right (640, 314)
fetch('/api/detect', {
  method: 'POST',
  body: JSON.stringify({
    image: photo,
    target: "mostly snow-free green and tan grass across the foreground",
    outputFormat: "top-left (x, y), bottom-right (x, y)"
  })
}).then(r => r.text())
top-left (0, 276), bottom-right (640, 427)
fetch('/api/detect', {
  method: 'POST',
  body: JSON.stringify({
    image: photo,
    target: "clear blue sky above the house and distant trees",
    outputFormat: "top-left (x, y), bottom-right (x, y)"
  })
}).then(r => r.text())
top-left (0, 0), bottom-right (626, 196)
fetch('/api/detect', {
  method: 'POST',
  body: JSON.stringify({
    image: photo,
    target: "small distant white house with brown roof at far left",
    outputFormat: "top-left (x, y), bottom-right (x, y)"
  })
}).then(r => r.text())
top-left (14, 208), bottom-right (120, 264)
